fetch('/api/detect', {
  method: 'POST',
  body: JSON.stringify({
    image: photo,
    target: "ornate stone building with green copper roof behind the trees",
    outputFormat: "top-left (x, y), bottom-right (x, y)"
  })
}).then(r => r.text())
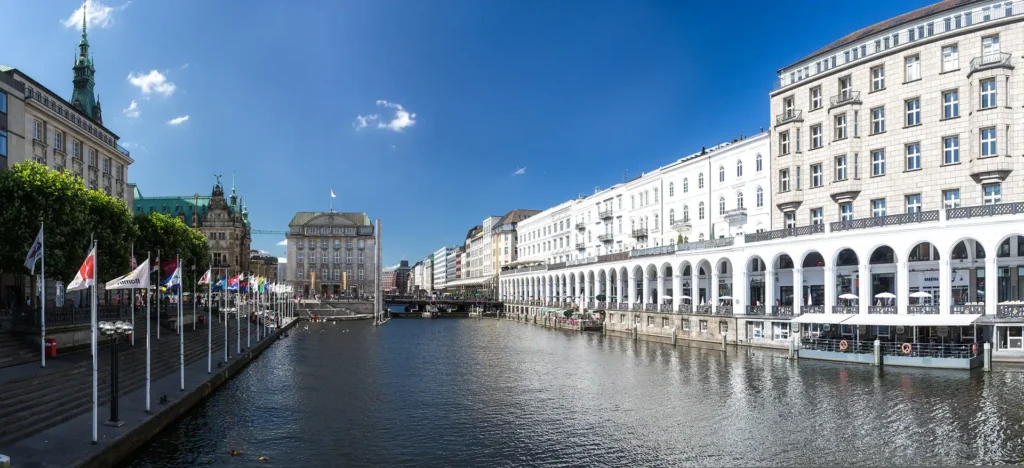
top-left (134, 176), bottom-right (252, 275)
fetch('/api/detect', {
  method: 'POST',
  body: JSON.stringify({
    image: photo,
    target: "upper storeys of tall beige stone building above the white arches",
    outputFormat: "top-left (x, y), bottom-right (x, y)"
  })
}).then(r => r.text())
top-left (771, 0), bottom-right (1024, 229)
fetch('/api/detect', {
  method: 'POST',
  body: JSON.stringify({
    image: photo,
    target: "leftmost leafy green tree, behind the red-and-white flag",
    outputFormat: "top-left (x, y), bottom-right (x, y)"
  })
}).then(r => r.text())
top-left (0, 161), bottom-right (92, 282)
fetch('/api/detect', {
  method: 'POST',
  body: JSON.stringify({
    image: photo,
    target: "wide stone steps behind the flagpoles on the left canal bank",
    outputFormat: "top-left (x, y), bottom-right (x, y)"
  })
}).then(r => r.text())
top-left (0, 321), bottom-right (255, 449)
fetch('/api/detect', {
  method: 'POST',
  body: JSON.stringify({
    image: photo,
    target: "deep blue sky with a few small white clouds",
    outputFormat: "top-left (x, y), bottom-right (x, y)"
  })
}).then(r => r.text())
top-left (0, 0), bottom-right (933, 264)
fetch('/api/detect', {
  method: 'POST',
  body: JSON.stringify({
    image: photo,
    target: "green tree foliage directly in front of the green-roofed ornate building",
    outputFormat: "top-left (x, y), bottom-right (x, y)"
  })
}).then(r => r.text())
top-left (135, 212), bottom-right (210, 284)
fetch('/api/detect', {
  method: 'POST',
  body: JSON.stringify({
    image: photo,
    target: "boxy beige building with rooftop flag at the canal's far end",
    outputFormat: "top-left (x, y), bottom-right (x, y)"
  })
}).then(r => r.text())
top-left (286, 211), bottom-right (377, 295)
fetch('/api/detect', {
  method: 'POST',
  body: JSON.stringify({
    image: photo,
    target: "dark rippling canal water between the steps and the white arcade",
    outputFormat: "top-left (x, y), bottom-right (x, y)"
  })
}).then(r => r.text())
top-left (127, 318), bottom-right (1024, 467)
